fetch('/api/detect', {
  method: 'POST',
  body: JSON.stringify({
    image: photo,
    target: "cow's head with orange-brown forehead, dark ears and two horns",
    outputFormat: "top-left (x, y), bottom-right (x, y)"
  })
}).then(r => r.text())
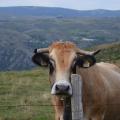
top-left (32, 42), bottom-right (100, 95)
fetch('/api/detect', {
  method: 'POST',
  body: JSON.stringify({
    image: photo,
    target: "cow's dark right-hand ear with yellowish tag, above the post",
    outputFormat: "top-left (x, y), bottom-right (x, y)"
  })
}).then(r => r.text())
top-left (76, 55), bottom-right (96, 68)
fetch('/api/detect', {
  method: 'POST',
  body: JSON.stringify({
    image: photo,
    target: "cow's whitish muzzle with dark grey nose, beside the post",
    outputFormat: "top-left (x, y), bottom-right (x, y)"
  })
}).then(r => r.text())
top-left (51, 80), bottom-right (72, 96)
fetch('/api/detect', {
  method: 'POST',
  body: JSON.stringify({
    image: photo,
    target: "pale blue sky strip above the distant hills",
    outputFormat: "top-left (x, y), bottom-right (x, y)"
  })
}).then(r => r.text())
top-left (0, 0), bottom-right (120, 10)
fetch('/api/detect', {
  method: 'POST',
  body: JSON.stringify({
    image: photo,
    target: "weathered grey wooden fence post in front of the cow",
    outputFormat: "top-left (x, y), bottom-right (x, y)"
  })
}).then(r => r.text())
top-left (71, 74), bottom-right (83, 120)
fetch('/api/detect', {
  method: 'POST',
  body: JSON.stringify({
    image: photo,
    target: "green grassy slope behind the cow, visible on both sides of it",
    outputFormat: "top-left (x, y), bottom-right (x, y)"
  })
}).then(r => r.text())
top-left (0, 43), bottom-right (120, 120)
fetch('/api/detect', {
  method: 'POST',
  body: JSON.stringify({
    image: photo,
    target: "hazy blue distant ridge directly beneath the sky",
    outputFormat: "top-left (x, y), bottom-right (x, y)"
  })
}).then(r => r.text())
top-left (0, 6), bottom-right (120, 18)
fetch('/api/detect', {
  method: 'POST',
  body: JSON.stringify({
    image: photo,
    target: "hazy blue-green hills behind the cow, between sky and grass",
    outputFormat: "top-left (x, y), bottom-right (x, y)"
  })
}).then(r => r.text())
top-left (0, 7), bottom-right (120, 71)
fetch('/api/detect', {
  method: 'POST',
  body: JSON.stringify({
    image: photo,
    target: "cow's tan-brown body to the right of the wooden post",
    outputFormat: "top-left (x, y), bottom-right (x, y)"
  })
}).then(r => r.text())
top-left (79, 62), bottom-right (120, 120)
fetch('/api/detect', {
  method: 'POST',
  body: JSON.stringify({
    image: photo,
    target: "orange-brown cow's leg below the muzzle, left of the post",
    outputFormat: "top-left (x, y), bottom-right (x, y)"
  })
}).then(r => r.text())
top-left (52, 96), bottom-right (64, 120)
